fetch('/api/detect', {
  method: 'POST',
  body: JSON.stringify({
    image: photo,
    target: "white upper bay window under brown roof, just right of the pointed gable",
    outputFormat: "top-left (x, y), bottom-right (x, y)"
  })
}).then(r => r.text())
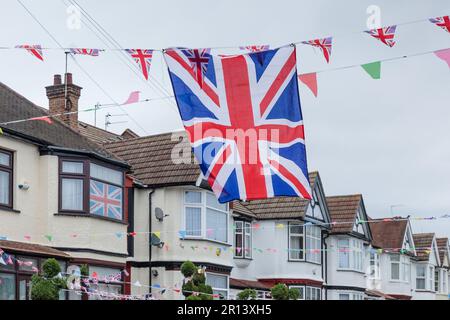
top-left (338, 238), bottom-right (364, 272)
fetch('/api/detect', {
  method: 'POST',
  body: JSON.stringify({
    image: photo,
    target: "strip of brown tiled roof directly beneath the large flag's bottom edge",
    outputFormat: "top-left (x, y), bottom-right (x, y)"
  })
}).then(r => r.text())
top-left (236, 172), bottom-right (319, 220)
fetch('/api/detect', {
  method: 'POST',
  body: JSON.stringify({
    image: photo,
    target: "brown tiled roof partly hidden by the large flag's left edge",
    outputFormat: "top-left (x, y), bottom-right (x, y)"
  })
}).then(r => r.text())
top-left (104, 132), bottom-right (200, 187)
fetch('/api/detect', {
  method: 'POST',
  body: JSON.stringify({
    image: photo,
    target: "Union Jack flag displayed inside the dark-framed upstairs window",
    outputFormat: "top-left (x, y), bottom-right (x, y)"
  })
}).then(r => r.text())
top-left (89, 180), bottom-right (122, 220)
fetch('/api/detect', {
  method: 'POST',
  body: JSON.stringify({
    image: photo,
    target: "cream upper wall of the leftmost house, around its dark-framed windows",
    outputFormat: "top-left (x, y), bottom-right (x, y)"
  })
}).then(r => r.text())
top-left (0, 136), bottom-right (127, 266)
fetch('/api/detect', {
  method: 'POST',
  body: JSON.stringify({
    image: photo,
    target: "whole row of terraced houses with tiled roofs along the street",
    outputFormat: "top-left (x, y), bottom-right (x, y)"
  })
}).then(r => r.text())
top-left (0, 74), bottom-right (450, 300)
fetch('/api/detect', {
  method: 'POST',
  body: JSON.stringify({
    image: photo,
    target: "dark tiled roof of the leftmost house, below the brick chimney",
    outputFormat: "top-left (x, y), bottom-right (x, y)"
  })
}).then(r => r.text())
top-left (0, 82), bottom-right (118, 161)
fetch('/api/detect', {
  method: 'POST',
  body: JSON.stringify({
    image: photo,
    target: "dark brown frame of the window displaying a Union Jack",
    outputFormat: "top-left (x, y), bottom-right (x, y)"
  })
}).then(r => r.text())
top-left (58, 156), bottom-right (126, 223)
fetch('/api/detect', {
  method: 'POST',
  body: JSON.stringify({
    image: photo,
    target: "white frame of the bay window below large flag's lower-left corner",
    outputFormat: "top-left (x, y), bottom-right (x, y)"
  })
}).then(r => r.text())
top-left (182, 189), bottom-right (230, 244)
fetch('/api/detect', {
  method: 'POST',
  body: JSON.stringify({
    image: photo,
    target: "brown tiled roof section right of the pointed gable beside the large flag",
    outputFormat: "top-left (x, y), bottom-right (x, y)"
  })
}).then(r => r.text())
top-left (326, 194), bottom-right (362, 233)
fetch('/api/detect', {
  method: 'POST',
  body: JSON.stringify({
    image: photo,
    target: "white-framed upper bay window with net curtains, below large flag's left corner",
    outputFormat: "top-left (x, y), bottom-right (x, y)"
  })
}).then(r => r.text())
top-left (184, 191), bottom-right (228, 243)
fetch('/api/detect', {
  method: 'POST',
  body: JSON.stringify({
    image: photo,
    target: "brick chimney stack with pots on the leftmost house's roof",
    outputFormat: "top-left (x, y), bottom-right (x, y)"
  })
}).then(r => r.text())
top-left (45, 73), bottom-right (83, 130)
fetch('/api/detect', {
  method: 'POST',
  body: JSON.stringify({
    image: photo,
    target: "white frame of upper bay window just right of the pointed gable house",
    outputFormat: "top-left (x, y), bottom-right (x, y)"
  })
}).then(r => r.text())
top-left (337, 237), bottom-right (365, 272)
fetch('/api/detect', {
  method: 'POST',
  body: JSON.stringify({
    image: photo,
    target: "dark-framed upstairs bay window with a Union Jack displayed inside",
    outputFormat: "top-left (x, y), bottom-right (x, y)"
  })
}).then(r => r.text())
top-left (60, 159), bottom-right (124, 220)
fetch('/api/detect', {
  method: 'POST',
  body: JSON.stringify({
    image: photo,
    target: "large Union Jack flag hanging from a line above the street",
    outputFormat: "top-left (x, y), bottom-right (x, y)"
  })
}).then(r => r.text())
top-left (165, 46), bottom-right (311, 203)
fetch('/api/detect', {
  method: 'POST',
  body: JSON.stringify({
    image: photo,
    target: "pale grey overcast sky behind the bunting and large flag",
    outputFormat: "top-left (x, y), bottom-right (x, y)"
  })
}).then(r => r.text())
top-left (0, 0), bottom-right (450, 236)
